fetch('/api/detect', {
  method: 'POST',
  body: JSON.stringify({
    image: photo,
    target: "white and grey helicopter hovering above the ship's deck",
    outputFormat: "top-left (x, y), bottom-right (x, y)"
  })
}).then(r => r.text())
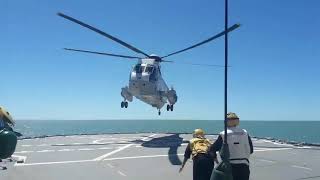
top-left (57, 13), bottom-right (240, 115)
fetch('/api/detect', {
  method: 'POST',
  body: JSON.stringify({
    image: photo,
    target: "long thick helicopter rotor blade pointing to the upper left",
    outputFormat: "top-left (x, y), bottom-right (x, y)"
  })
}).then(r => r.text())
top-left (57, 13), bottom-right (149, 57)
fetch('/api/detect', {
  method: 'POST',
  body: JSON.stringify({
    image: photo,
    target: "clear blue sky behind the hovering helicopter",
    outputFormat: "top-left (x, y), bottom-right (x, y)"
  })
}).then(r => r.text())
top-left (0, 0), bottom-right (320, 120)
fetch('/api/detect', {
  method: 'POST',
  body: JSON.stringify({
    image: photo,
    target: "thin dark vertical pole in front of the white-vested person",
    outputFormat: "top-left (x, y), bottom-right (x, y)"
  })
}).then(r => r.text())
top-left (224, 0), bottom-right (228, 144)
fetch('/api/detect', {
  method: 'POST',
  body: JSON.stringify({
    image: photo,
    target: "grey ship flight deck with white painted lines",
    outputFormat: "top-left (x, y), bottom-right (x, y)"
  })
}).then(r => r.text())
top-left (0, 134), bottom-right (320, 180)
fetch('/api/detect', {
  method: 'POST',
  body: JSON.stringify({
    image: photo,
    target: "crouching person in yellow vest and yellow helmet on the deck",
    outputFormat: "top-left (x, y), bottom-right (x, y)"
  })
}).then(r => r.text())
top-left (179, 129), bottom-right (216, 180)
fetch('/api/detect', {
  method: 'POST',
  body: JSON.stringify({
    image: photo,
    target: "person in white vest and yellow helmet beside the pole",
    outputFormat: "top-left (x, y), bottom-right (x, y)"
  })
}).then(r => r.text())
top-left (210, 112), bottom-right (253, 180)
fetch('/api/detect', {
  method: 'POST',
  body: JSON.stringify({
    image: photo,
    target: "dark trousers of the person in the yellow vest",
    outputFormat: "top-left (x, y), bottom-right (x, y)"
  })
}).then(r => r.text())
top-left (193, 154), bottom-right (214, 180)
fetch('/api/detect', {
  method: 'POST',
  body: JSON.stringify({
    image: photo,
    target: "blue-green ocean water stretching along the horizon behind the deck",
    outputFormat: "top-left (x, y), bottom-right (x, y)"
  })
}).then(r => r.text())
top-left (15, 120), bottom-right (320, 144)
